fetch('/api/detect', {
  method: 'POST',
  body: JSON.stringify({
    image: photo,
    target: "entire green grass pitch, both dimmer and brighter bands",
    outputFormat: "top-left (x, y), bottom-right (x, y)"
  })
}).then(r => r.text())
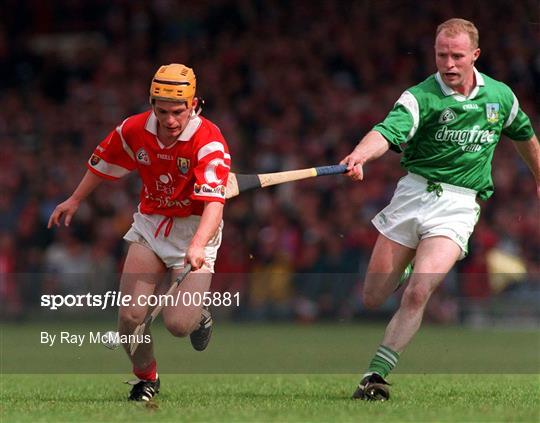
top-left (0, 319), bottom-right (540, 423)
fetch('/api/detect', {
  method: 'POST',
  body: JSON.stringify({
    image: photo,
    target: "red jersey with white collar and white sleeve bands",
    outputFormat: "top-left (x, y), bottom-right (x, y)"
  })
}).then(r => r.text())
top-left (87, 110), bottom-right (231, 217)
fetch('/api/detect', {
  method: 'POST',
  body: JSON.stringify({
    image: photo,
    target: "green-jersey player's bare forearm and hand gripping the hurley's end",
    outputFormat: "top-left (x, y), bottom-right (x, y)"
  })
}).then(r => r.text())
top-left (339, 131), bottom-right (389, 181)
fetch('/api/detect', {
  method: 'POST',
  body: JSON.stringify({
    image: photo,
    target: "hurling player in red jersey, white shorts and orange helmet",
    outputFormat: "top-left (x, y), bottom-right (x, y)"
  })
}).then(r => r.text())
top-left (48, 64), bottom-right (231, 401)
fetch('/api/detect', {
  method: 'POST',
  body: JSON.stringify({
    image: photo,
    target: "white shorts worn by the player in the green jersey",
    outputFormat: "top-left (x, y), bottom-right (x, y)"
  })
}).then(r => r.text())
top-left (371, 173), bottom-right (480, 260)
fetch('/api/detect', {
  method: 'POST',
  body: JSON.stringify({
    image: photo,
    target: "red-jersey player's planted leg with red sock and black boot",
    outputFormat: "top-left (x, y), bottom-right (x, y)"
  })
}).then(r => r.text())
top-left (118, 243), bottom-right (162, 401)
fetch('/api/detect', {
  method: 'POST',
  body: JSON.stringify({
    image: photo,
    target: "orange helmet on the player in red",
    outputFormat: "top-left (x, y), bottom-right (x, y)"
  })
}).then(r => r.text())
top-left (150, 63), bottom-right (197, 107)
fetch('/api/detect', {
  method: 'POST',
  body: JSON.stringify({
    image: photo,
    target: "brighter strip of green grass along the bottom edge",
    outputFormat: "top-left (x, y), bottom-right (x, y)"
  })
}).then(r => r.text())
top-left (0, 375), bottom-right (540, 422)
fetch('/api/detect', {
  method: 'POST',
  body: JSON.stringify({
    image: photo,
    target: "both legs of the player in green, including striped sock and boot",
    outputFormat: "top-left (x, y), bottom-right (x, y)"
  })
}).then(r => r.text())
top-left (353, 235), bottom-right (460, 401)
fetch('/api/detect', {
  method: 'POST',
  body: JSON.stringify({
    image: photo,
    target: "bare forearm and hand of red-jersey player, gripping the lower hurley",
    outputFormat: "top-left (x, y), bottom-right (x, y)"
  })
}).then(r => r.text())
top-left (186, 201), bottom-right (224, 270)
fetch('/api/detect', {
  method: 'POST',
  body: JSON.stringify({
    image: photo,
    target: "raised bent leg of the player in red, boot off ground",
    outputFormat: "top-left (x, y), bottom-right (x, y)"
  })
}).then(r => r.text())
top-left (163, 267), bottom-right (212, 350)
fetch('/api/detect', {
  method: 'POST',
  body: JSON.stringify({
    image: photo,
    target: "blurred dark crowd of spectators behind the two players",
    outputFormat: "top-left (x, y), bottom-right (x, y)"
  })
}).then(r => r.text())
top-left (0, 0), bottom-right (540, 322)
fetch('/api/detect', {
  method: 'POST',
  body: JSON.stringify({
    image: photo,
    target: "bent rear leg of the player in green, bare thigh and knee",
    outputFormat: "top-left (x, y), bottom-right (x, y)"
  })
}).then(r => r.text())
top-left (363, 234), bottom-right (415, 309)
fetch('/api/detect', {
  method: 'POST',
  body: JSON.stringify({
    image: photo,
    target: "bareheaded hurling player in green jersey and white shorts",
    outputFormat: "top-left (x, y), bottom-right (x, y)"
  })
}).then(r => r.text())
top-left (341, 19), bottom-right (540, 400)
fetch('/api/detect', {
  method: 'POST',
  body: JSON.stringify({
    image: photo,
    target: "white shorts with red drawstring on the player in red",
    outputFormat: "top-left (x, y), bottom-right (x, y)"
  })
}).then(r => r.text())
top-left (124, 212), bottom-right (223, 273)
